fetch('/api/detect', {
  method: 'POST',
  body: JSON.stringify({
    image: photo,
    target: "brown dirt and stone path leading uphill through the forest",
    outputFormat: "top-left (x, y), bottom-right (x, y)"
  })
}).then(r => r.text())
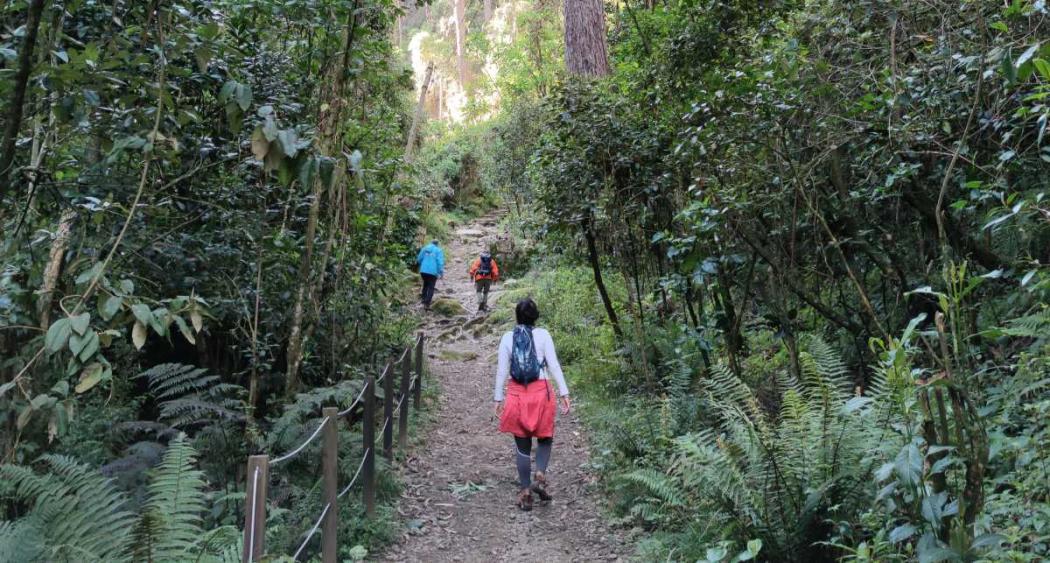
top-left (383, 212), bottom-right (629, 562)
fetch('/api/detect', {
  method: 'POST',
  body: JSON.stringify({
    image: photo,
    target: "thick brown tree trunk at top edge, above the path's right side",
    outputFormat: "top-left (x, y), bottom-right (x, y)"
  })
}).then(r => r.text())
top-left (565, 0), bottom-right (609, 77)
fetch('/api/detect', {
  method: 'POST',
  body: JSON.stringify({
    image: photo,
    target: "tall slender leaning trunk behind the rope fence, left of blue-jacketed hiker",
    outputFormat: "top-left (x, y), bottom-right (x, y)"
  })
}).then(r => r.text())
top-left (285, 8), bottom-right (357, 395)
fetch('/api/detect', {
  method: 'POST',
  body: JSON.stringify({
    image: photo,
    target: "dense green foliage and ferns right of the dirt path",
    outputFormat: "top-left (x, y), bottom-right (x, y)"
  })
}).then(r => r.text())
top-left (482, 0), bottom-right (1050, 561)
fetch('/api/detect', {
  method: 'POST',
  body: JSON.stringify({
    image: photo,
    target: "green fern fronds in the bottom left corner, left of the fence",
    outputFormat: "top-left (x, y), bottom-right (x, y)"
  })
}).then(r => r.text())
top-left (0, 435), bottom-right (240, 563)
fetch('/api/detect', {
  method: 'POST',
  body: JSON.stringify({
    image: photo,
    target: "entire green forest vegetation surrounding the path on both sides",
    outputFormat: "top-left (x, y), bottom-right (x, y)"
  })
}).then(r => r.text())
top-left (0, 0), bottom-right (1050, 562)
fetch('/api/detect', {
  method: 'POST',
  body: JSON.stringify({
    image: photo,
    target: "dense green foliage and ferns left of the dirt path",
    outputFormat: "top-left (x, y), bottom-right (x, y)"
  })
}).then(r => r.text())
top-left (0, 0), bottom-right (421, 561)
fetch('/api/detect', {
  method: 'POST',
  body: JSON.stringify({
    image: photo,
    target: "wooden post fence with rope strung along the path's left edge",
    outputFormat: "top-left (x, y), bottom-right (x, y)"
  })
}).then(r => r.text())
top-left (242, 332), bottom-right (425, 563)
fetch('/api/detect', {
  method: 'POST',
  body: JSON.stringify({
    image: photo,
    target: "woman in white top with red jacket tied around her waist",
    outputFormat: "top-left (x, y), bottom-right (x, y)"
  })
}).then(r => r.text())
top-left (496, 299), bottom-right (571, 510)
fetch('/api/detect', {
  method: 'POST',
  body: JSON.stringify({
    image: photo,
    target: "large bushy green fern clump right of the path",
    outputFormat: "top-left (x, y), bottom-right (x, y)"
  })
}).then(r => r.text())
top-left (663, 338), bottom-right (878, 561)
